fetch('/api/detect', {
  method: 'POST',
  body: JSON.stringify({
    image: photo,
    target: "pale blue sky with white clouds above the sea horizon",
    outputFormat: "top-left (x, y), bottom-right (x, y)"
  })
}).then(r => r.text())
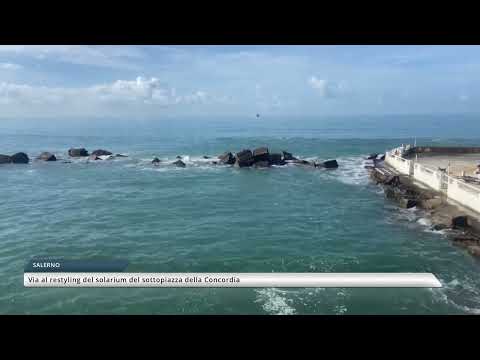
top-left (0, 45), bottom-right (480, 119)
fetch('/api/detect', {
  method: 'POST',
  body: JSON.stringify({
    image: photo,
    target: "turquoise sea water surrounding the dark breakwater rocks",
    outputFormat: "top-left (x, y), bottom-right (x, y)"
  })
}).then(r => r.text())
top-left (0, 116), bottom-right (480, 314)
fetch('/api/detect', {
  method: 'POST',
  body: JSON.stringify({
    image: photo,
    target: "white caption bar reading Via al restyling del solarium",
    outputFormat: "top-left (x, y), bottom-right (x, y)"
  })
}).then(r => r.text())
top-left (24, 273), bottom-right (442, 288)
